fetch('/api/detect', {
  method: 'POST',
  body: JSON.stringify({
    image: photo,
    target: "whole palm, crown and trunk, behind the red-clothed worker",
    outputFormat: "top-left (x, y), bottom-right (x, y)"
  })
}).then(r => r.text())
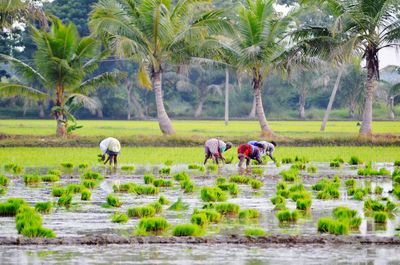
top-left (222, 0), bottom-right (289, 136)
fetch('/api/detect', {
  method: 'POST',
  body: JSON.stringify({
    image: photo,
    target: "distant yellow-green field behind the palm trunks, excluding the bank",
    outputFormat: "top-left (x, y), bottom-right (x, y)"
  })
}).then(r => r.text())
top-left (0, 120), bottom-right (400, 138)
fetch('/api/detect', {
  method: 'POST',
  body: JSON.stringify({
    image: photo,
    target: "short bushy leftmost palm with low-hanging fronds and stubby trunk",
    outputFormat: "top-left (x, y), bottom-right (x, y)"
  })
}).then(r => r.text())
top-left (0, 18), bottom-right (120, 136)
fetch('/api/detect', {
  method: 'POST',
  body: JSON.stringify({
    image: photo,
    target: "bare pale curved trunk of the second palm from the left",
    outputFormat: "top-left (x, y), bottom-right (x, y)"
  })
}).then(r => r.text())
top-left (153, 71), bottom-right (175, 135)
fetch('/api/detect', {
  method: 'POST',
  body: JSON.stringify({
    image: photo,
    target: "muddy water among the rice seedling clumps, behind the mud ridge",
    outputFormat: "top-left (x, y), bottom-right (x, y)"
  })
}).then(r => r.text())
top-left (0, 163), bottom-right (400, 237)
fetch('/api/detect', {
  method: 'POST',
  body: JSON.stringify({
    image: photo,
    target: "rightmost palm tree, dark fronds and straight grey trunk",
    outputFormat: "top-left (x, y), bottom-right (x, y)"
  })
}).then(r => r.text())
top-left (303, 0), bottom-right (400, 135)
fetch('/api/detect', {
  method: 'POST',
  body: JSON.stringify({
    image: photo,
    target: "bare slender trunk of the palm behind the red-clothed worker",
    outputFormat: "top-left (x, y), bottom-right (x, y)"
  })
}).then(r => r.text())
top-left (253, 69), bottom-right (274, 137)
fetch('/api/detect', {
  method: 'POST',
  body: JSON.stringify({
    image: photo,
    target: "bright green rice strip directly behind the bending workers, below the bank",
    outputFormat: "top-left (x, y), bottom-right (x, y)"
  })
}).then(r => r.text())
top-left (0, 146), bottom-right (400, 166)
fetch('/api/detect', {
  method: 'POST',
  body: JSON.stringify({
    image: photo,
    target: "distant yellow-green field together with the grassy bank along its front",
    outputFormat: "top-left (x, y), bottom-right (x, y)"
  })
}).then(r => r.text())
top-left (0, 120), bottom-right (400, 147)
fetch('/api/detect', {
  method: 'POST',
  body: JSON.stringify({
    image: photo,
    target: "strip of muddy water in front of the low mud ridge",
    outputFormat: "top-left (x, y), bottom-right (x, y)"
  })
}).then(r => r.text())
top-left (0, 242), bottom-right (400, 265)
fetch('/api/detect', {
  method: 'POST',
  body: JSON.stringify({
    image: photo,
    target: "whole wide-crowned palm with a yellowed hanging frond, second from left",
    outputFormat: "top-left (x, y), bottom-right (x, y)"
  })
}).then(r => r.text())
top-left (89, 0), bottom-right (229, 134)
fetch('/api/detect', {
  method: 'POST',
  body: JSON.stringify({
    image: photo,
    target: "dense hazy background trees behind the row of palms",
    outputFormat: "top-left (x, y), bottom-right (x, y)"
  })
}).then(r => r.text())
top-left (0, 0), bottom-right (400, 136)
